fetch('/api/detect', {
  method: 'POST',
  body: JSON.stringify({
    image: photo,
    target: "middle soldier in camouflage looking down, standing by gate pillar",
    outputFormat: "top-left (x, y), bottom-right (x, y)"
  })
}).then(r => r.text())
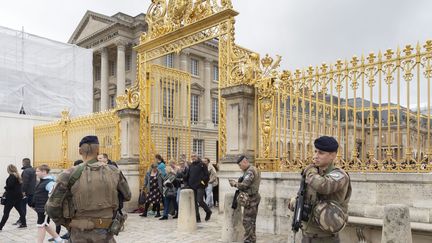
top-left (229, 155), bottom-right (261, 243)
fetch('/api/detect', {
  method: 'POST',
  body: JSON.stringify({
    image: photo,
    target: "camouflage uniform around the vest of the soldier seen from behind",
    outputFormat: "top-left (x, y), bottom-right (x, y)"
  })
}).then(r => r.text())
top-left (51, 159), bottom-right (131, 243)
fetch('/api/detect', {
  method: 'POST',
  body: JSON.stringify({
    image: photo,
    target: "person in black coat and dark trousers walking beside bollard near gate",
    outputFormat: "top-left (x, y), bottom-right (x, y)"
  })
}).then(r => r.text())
top-left (184, 154), bottom-right (212, 222)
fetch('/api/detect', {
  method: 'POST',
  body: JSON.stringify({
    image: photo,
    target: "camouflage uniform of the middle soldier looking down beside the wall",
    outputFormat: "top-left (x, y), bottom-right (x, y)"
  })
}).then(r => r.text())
top-left (237, 165), bottom-right (261, 243)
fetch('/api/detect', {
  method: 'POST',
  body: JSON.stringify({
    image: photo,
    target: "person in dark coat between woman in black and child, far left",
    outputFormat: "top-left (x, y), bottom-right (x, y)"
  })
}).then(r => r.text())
top-left (13, 158), bottom-right (36, 225)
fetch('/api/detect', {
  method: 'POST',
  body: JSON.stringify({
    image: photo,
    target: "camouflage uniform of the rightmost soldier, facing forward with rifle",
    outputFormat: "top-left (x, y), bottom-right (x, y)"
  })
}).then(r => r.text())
top-left (302, 163), bottom-right (351, 243)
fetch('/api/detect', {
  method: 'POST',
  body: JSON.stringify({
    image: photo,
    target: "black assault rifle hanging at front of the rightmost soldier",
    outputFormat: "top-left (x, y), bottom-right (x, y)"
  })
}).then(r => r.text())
top-left (292, 173), bottom-right (311, 242)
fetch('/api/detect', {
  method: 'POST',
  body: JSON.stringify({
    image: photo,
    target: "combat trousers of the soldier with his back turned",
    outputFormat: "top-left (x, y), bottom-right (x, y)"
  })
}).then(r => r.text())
top-left (70, 228), bottom-right (116, 243)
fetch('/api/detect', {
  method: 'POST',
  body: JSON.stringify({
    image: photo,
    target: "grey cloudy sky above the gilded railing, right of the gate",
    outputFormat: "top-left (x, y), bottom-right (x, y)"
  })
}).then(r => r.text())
top-left (235, 0), bottom-right (432, 69)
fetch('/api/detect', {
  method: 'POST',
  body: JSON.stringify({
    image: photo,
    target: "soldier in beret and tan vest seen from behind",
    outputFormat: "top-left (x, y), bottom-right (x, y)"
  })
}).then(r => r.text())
top-left (46, 136), bottom-right (131, 243)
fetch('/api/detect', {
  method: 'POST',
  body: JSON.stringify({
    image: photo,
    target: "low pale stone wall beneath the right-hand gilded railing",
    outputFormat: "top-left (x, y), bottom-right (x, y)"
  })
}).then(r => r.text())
top-left (219, 171), bottom-right (432, 243)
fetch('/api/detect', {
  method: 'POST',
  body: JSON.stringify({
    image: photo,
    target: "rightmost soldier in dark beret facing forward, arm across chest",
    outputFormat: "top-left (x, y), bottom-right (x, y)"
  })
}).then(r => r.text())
top-left (288, 136), bottom-right (351, 243)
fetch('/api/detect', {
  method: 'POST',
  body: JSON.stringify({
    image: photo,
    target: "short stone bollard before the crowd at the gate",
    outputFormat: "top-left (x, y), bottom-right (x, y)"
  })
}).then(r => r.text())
top-left (177, 189), bottom-right (197, 232)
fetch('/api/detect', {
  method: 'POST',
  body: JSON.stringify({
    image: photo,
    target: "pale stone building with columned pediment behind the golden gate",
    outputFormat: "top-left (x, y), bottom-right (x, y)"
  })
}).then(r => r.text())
top-left (69, 11), bottom-right (219, 162)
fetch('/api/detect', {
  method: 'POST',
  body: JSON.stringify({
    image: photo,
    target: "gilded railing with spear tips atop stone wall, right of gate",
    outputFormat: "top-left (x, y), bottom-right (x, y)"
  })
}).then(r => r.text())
top-left (255, 41), bottom-right (432, 172)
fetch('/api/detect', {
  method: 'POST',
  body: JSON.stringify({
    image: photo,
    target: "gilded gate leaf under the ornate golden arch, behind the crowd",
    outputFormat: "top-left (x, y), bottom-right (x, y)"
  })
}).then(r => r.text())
top-left (148, 65), bottom-right (192, 161)
